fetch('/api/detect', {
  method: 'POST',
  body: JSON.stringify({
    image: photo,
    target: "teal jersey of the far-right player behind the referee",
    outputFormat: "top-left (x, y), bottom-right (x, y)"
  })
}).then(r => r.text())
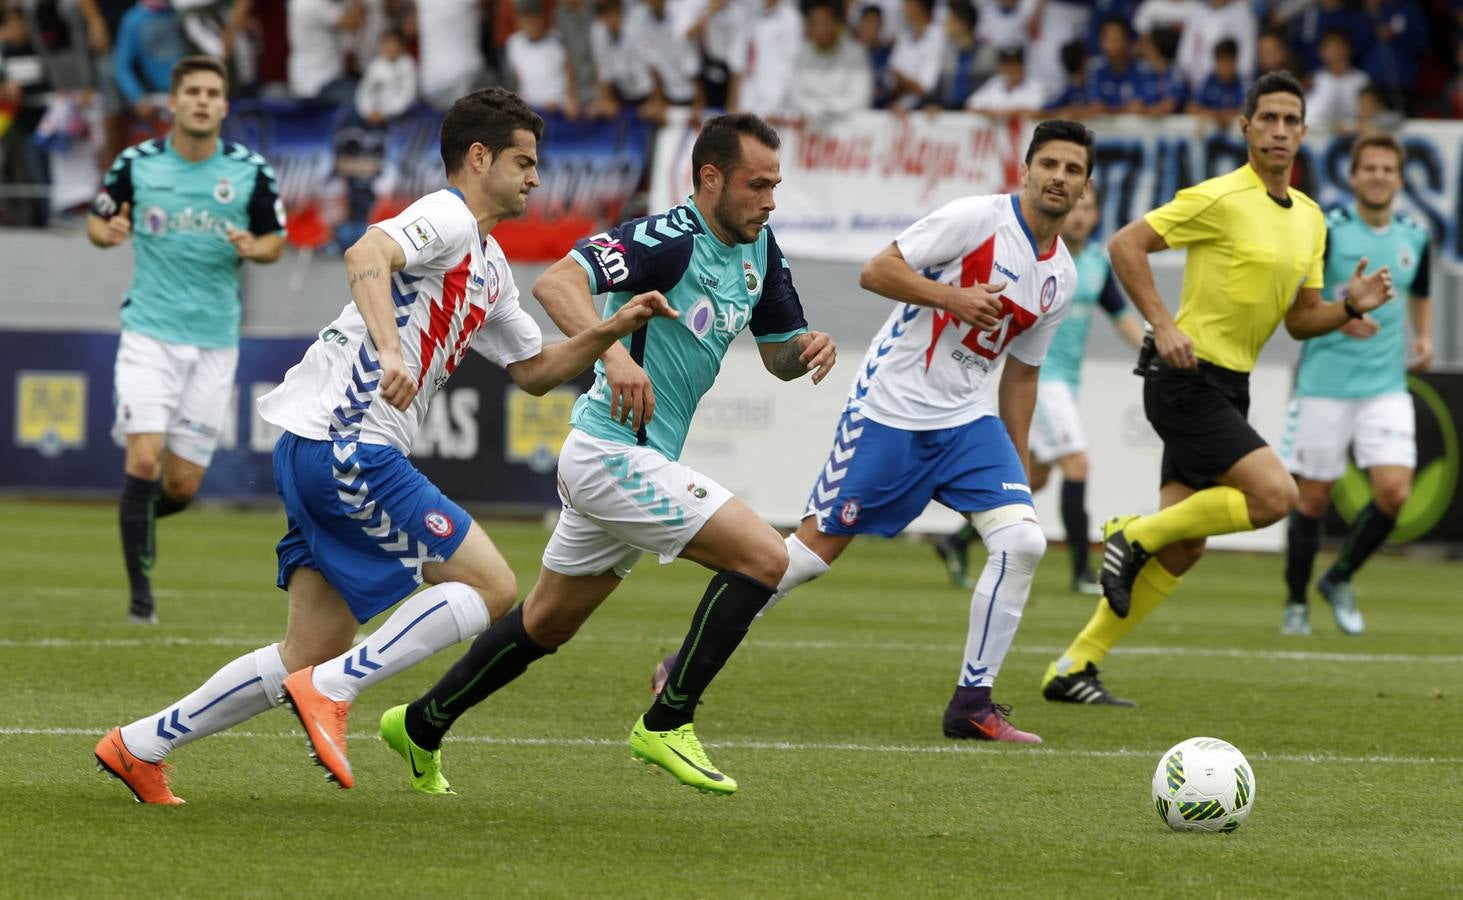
top-left (1295, 205), bottom-right (1429, 398)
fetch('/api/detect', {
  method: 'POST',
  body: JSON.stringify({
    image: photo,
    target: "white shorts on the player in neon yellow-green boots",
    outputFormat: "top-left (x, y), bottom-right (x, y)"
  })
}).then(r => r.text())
top-left (543, 429), bottom-right (732, 578)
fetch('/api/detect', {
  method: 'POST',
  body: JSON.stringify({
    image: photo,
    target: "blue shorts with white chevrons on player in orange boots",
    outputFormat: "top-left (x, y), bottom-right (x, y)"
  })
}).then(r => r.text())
top-left (274, 432), bottom-right (473, 622)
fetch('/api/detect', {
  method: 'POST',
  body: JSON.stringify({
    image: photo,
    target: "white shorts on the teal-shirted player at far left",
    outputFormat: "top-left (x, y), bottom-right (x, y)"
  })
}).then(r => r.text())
top-left (111, 331), bottom-right (238, 468)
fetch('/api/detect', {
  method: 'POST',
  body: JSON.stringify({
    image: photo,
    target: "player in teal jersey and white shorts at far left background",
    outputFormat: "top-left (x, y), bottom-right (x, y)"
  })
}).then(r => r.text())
top-left (86, 56), bottom-right (284, 623)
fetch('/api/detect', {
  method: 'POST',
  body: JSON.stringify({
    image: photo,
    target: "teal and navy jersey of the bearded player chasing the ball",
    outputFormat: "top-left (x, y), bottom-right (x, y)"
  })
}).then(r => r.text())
top-left (569, 200), bottom-right (808, 460)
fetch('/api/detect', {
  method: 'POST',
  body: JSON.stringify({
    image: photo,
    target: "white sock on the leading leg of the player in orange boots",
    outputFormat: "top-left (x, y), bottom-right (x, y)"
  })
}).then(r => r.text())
top-left (310, 581), bottom-right (487, 701)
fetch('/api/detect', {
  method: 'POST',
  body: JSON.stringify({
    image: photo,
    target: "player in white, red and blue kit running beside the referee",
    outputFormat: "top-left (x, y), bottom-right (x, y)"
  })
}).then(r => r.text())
top-left (661, 120), bottom-right (1093, 743)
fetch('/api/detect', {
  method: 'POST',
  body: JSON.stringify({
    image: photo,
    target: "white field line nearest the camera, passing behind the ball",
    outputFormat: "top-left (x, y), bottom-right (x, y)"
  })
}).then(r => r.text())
top-left (0, 727), bottom-right (1463, 765)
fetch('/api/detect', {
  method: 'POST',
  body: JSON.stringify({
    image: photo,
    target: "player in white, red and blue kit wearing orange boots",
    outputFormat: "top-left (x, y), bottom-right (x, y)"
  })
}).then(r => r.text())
top-left (95, 88), bottom-right (674, 805)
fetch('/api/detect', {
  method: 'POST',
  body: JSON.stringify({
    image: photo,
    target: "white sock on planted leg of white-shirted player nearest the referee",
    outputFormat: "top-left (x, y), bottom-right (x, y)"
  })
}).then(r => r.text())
top-left (955, 521), bottom-right (1046, 688)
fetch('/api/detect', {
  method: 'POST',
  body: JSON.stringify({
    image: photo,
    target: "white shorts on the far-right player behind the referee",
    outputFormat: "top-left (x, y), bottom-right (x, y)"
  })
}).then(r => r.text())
top-left (1282, 394), bottom-right (1418, 481)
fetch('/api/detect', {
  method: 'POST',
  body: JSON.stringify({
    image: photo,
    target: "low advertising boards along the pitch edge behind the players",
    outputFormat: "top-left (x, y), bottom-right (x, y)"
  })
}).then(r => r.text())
top-left (0, 331), bottom-right (1463, 550)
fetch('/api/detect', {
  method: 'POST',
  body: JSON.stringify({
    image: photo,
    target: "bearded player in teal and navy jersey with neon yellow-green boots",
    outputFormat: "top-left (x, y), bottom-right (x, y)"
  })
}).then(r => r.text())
top-left (382, 114), bottom-right (835, 793)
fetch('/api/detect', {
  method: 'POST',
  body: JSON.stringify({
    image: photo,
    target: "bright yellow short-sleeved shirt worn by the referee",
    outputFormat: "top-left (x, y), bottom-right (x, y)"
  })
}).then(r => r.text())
top-left (1143, 162), bottom-right (1325, 372)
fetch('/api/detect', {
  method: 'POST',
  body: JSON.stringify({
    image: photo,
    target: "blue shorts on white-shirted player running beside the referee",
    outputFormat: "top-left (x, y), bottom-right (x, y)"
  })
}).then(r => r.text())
top-left (803, 411), bottom-right (1031, 537)
